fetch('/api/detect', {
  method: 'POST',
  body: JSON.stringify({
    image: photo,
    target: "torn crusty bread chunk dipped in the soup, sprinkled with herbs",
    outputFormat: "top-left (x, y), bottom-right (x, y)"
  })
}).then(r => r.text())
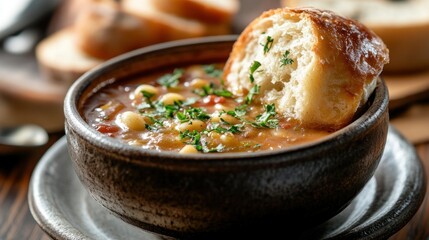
top-left (224, 8), bottom-right (389, 129)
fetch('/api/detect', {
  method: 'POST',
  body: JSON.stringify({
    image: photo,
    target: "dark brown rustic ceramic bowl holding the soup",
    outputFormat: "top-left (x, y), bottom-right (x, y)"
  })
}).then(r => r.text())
top-left (64, 36), bottom-right (388, 237)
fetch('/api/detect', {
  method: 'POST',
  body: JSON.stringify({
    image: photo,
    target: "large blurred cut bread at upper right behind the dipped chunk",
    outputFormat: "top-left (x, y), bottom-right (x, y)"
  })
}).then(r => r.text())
top-left (281, 0), bottom-right (429, 73)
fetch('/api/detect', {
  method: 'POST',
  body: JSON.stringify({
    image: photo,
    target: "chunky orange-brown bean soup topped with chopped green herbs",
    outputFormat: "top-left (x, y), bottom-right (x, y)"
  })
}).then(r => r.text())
top-left (83, 64), bottom-right (329, 153)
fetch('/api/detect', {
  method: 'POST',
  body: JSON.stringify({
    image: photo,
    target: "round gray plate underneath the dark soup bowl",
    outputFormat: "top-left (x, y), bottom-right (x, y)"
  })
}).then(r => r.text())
top-left (29, 127), bottom-right (426, 240)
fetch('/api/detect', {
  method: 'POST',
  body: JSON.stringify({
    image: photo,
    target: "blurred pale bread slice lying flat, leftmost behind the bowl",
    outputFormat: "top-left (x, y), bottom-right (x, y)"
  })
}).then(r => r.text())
top-left (36, 28), bottom-right (103, 86)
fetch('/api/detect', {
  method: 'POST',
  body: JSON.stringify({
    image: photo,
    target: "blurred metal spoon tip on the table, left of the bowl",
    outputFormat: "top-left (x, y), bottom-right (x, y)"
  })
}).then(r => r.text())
top-left (0, 124), bottom-right (49, 153)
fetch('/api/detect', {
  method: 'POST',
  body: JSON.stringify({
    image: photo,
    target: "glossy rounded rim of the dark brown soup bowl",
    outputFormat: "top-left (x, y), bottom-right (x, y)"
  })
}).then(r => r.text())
top-left (63, 35), bottom-right (389, 165)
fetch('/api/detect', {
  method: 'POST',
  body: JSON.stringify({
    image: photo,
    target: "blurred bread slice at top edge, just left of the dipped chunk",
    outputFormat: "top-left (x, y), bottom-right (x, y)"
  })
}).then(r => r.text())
top-left (151, 0), bottom-right (240, 24)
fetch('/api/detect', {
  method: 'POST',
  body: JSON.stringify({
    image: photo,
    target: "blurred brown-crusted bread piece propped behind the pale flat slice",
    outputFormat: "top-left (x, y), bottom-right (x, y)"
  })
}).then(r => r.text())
top-left (74, 1), bottom-right (161, 59)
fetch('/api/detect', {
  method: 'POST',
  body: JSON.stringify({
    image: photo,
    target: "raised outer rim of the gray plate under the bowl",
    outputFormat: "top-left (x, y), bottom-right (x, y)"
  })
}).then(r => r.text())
top-left (28, 125), bottom-right (426, 239)
